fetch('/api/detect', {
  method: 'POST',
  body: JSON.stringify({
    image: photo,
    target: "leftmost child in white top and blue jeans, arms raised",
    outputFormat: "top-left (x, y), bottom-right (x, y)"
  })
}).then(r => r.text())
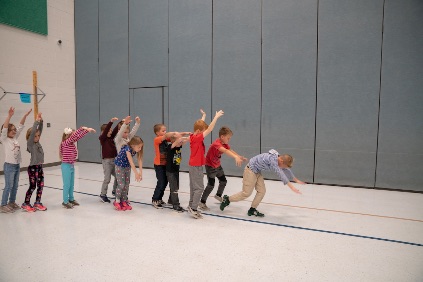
top-left (0, 107), bottom-right (32, 213)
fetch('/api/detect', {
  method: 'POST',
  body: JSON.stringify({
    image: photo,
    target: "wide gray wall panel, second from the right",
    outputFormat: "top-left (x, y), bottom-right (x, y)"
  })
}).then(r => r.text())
top-left (315, 0), bottom-right (383, 186)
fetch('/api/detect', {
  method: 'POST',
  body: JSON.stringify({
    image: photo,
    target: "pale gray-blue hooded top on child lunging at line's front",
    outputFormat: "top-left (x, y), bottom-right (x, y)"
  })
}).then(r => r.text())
top-left (248, 150), bottom-right (295, 185)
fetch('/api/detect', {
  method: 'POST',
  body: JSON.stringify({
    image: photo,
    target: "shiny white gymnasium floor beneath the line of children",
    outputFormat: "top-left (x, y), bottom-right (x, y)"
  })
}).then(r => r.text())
top-left (0, 163), bottom-right (423, 282)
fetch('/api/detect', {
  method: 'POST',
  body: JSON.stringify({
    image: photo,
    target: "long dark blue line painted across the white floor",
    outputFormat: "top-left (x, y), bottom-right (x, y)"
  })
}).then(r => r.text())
top-left (44, 186), bottom-right (423, 247)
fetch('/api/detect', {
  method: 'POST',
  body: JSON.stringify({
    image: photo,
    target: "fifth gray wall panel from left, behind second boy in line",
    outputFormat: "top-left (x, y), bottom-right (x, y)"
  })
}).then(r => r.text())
top-left (212, 0), bottom-right (261, 175)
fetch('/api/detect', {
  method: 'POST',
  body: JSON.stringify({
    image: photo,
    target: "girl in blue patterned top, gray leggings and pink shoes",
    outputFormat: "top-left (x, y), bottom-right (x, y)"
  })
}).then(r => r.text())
top-left (113, 136), bottom-right (144, 211)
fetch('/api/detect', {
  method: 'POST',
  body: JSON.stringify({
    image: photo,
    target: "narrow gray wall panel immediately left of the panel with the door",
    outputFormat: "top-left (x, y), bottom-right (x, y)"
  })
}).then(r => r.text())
top-left (99, 0), bottom-right (129, 123)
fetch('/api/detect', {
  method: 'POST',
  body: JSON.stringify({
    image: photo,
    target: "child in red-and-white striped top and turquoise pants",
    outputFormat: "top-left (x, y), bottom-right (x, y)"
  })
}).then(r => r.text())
top-left (59, 126), bottom-right (95, 209)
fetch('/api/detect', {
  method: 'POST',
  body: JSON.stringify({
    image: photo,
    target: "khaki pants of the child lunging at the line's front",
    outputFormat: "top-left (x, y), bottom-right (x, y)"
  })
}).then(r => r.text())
top-left (229, 166), bottom-right (266, 208)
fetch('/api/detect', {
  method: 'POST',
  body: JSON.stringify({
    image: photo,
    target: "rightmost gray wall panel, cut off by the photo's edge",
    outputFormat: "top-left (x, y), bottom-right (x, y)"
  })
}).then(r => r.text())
top-left (376, 0), bottom-right (423, 191)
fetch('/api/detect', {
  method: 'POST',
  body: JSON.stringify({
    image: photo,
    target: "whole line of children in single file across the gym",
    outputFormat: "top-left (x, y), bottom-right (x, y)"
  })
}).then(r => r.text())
top-left (0, 107), bottom-right (305, 218)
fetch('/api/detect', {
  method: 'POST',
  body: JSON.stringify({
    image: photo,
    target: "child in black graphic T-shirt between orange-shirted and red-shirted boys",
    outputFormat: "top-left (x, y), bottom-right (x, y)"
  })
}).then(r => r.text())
top-left (166, 135), bottom-right (189, 212)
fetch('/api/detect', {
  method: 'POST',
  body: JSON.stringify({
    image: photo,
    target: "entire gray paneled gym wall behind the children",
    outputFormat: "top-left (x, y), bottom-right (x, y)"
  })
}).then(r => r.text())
top-left (75, 0), bottom-right (423, 191)
